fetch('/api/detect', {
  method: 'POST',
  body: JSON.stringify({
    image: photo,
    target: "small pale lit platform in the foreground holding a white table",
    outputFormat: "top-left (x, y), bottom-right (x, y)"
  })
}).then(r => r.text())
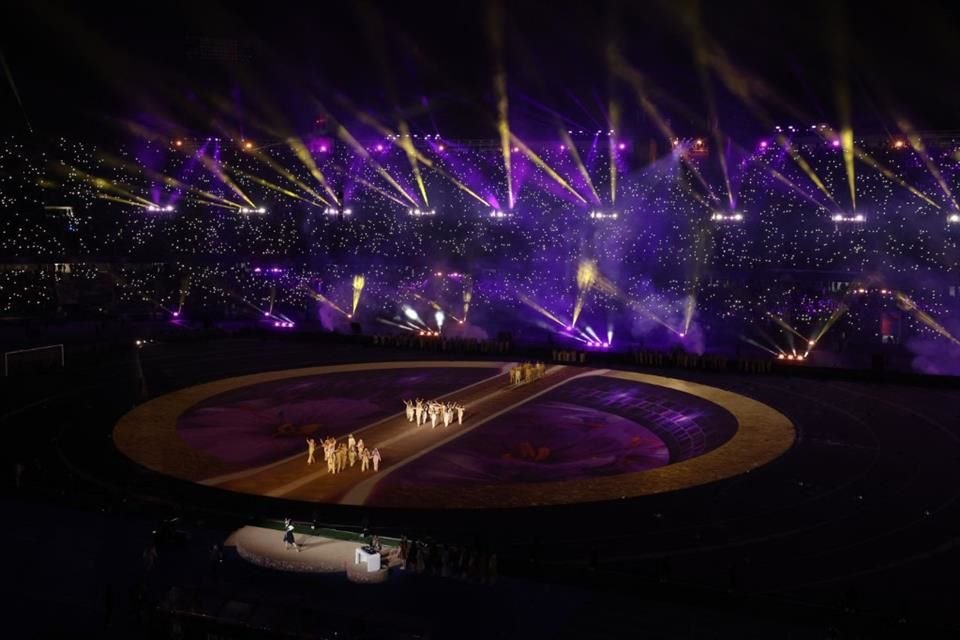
top-left (226, 527), bottom-right (401, 584)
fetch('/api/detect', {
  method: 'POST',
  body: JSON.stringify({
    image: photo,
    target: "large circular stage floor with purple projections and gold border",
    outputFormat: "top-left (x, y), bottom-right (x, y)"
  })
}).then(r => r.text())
top-left (113, 361), bottom-right (795, 509)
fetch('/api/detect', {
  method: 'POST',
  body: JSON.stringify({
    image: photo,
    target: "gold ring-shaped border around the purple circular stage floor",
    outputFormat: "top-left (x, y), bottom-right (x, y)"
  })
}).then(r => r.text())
top-left (113, 361), bottom-right (796, 509)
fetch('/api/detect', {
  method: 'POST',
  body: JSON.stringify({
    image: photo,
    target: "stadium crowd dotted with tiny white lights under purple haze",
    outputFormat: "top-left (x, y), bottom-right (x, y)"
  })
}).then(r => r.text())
top-left (0, 131), bottom-right (960, 370)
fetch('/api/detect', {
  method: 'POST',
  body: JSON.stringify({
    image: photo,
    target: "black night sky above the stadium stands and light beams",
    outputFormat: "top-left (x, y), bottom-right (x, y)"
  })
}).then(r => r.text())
top-left (0, 0), bottom-right (960, 137)
